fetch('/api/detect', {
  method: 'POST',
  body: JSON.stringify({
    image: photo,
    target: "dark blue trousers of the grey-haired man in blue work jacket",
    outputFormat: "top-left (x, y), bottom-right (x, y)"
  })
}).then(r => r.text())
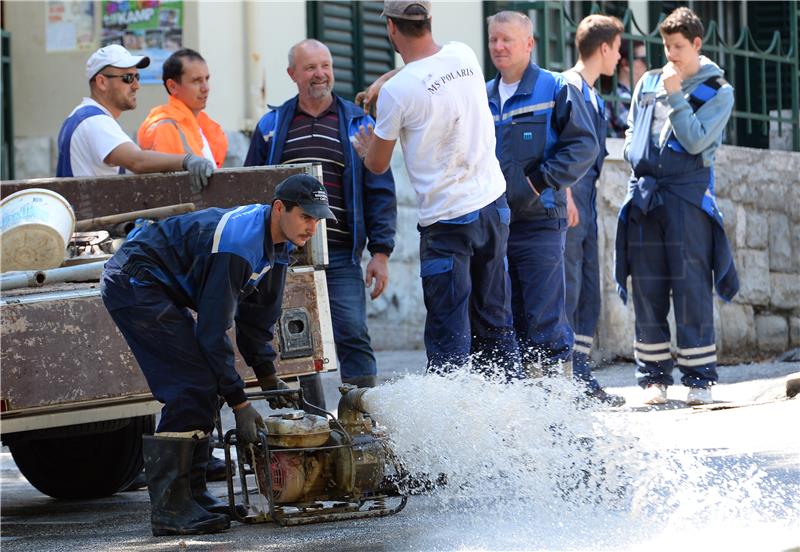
top-left (508, 219), bottom-right (573, 366)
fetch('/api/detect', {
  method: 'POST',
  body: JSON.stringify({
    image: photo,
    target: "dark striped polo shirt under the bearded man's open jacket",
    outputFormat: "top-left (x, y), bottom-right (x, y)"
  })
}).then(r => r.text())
top-left (281, 100), bottom-right (353, 248)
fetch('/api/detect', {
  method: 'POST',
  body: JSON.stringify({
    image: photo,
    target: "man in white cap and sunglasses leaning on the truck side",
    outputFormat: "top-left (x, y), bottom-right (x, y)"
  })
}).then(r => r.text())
top-left (56, 44), bottom-right (214, 192)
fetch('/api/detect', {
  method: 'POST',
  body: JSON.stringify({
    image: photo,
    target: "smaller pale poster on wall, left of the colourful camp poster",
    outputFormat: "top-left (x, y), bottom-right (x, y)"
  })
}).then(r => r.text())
top-left (45, 0), bottom-right (95, 52)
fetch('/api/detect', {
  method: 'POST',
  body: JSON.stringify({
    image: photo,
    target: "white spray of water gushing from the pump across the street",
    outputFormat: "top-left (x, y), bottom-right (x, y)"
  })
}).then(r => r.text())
top-left (365, 371), bottom-right (800, 551)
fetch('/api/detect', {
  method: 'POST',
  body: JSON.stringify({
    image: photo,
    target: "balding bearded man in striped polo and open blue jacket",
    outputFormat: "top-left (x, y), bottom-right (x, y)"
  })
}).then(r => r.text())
top-left (244, 39), bottom-right (397, 387)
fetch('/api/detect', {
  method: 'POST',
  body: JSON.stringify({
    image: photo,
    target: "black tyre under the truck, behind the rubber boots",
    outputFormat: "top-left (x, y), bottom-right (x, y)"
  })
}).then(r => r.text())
top-left (8, 416), bottom-right (155, 499)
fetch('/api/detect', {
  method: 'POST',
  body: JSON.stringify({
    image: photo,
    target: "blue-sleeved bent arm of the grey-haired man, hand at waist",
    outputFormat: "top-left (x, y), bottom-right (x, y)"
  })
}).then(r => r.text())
top-left (525, 83), bottom-right (600, 194)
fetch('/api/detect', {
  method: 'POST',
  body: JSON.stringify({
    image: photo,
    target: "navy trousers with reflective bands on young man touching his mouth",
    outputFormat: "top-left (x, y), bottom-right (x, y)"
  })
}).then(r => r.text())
top-left (628, 192), bottom-right (718, 387)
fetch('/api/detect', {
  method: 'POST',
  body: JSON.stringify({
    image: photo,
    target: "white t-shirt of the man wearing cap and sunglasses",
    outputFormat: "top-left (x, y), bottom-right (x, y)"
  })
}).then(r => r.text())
top-left (69, 98), bottom-right (133, 176)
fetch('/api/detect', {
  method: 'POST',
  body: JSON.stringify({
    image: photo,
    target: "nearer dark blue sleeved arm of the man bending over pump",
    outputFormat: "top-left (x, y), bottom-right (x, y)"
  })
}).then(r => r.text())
top-left (195, 253), bottom-right (253, 406)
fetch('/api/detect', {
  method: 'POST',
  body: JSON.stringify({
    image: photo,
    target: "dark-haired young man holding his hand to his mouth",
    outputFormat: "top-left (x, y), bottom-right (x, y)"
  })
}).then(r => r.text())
top-left (615, 8), bottom-right (739, 405)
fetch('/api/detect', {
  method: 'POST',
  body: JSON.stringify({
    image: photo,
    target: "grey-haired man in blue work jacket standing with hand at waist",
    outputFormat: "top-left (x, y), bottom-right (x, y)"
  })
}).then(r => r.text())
top-left (486, 11), bottom-right (599, 375)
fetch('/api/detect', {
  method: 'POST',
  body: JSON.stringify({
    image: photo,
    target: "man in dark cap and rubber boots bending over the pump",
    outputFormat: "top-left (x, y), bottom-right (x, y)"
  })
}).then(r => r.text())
top-left (101, 175), bottom-right (335, 536)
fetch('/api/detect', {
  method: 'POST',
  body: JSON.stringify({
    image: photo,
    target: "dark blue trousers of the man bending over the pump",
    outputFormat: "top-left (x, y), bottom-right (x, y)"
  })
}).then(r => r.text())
top-left (100, 262), bottom-right (219, 433)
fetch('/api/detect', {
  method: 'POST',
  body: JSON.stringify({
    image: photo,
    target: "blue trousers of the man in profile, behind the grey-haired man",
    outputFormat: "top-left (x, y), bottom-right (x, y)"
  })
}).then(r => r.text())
top-left (564, 207), bottom-right (600, 391)
